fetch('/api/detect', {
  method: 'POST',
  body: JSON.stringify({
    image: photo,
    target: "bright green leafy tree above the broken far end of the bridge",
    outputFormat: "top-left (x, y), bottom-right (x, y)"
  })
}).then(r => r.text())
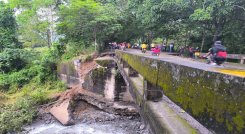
top-left (58, 0), bottom-right (121, 48)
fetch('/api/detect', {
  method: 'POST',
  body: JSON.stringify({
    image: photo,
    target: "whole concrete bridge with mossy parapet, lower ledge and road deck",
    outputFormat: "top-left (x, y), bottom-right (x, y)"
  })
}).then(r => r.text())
top-left (115, 50), bottom-right (245, 134)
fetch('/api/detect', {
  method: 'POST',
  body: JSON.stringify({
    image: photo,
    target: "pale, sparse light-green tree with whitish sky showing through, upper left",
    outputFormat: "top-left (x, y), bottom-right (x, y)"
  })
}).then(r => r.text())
top-left (10, 0), bottom-right (62, 47)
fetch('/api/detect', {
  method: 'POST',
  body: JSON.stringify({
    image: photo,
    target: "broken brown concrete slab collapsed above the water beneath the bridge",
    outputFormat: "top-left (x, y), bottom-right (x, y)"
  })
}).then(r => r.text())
top-left (50, 88), bottom-right (139, 126)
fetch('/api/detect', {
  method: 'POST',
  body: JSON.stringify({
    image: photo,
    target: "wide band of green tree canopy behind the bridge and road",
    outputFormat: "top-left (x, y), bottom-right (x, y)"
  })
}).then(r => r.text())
top-left (3, 0), bottom-right (245, 53)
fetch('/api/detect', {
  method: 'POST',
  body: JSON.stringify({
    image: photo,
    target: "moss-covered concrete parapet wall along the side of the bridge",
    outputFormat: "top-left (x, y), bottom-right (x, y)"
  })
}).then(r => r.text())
top-left (116, 51), bottom-right (245, 133)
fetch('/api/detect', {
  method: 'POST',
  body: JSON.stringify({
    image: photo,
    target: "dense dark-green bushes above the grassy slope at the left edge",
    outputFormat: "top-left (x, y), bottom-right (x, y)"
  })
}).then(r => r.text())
top-left (0, 45), bottom-right (63, 91)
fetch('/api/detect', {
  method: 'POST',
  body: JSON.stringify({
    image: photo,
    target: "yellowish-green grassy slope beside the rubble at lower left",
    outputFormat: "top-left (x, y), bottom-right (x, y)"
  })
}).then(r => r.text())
top-left (0, 81), bottom-right (65, 134)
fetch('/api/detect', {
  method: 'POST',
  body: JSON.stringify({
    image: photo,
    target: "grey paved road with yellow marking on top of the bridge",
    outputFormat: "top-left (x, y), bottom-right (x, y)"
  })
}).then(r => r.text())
top-left (120, 49), bottom-right (245, 78)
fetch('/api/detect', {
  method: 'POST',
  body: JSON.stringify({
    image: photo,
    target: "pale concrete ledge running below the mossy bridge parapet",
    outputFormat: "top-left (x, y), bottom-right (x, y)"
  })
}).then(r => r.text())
top-left (115, 56), bottom-right (199, 134)
